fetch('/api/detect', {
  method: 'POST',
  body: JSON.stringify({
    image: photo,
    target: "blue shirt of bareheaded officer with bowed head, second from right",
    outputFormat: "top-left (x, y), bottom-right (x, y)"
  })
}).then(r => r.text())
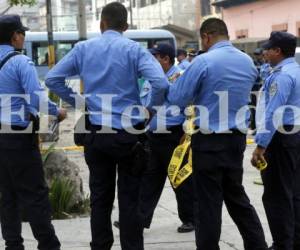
top-left (168, 41), bottom-right (258, 133)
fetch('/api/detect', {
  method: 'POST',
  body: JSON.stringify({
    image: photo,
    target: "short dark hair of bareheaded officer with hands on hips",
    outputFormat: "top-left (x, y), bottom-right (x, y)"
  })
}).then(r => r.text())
top-left (101, 2), bottom-right (128, 30)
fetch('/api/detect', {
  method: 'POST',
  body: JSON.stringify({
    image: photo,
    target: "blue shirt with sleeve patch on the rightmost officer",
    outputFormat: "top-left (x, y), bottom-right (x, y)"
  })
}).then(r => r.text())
top-left (255, 58), bottom-right (300, 148)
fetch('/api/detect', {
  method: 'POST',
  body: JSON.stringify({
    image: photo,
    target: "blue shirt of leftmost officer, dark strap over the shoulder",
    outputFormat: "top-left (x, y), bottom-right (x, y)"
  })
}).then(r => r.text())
top-left (0, 45), bottom-right (58, 127)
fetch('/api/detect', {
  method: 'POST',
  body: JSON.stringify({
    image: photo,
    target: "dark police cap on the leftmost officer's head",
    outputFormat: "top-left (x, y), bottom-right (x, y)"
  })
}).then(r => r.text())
top-left (0, 15), bottom-right (29, 35)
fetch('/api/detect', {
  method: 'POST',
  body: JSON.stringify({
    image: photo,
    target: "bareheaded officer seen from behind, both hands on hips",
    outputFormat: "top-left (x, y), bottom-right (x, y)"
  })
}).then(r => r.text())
top-left (46, 2), bottom-right (168, 250)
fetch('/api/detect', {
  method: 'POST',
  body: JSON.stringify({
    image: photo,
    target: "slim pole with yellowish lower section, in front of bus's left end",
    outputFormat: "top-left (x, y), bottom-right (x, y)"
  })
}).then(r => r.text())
top-left (46, 0), bottom-right (55, 69)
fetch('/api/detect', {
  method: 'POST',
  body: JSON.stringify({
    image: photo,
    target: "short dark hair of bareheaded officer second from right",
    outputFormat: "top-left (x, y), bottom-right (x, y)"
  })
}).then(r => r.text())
top-left (200, 17), bottom-right (229, 37)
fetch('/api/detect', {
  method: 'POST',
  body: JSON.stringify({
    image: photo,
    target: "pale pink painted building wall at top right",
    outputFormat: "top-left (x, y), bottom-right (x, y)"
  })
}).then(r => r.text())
top-left (223, 0), bottom-right (300, 40)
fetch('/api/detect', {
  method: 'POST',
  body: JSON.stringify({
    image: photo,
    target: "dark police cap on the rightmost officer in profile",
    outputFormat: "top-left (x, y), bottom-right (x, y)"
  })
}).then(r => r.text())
top-left (263, 31), bottom-right (297, 50)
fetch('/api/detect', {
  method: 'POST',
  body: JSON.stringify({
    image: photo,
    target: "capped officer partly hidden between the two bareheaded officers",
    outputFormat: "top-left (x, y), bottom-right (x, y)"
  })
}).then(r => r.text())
top-left (140, 43), bottom-right (194, 233)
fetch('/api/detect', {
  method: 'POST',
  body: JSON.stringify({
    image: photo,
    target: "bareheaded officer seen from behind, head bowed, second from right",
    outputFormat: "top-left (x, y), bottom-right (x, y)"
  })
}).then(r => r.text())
top-left (168, 18), bottom-right (267, 250)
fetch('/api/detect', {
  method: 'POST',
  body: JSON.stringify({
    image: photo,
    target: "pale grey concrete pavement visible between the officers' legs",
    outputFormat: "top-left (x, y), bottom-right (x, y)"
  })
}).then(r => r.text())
top-left (0, 114), bottom-right (271, 250)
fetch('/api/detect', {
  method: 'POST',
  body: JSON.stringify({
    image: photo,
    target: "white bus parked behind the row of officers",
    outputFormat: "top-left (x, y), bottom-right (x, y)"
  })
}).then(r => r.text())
top-left (24, 29), bottom-right (176, 79)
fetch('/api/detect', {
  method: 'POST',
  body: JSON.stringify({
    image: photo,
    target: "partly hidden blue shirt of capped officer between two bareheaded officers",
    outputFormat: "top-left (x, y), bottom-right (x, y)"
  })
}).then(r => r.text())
top-left (141, 65), bottom-right (185, 131)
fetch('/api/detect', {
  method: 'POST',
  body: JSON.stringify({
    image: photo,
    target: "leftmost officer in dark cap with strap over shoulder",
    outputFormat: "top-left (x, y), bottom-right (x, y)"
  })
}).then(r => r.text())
top-left (0, 15), bottom-right (66, 250)
